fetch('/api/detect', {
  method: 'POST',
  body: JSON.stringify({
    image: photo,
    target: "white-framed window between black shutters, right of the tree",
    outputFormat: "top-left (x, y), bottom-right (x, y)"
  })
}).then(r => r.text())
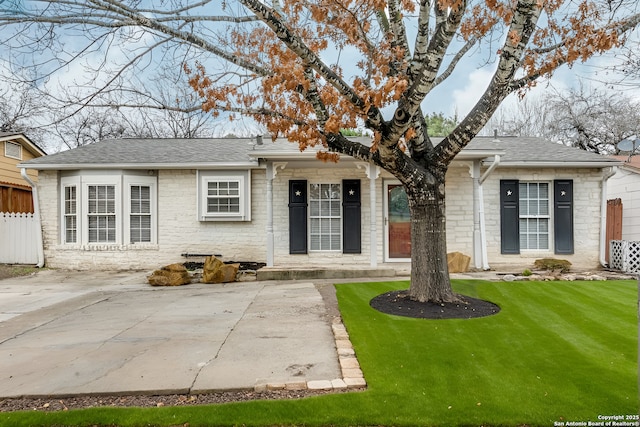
top-left (519, 182), bottom-right (550, 250)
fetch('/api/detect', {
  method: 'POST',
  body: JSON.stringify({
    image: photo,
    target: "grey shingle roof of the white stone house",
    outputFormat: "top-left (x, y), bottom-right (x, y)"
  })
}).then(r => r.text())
top-left (19, 137), bottom-right (620, 169)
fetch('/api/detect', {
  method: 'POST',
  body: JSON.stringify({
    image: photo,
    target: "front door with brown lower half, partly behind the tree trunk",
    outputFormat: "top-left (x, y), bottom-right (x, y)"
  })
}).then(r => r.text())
top-left (384, 182), bottom-right (411, 262)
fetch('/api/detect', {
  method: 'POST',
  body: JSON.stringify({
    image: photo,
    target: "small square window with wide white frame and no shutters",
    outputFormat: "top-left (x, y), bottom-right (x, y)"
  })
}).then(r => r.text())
top-left (198, 171), bottom-right (251, 221)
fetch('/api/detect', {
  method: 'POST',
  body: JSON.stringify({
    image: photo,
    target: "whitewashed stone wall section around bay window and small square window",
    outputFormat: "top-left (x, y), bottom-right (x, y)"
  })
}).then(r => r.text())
top-left (39, 170), bottom-right (266, 269)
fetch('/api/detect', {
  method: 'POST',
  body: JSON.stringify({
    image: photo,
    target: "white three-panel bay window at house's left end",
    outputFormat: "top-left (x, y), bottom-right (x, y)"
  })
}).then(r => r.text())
top-left (60, 171), bottom-right (157, 245)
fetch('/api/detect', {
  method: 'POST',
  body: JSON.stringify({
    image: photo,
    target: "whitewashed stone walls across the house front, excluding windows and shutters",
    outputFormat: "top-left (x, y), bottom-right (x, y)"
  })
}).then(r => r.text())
top-left (38, 164), bottom-right (601, 269)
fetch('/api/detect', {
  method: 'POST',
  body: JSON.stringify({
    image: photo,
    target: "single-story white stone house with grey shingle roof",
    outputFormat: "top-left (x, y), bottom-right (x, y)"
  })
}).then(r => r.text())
top-left (20, 138), bottom-right (619, 269)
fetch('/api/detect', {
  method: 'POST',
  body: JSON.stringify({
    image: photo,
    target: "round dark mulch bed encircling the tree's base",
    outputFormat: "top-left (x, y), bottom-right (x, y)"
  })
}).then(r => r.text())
top-left (369, 290), bottom-right (500, 319)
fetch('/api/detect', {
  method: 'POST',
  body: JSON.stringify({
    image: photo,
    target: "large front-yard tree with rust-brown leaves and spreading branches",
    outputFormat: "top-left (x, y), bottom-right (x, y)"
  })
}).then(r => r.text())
top-left (0, 0), bottom-right (640, 302)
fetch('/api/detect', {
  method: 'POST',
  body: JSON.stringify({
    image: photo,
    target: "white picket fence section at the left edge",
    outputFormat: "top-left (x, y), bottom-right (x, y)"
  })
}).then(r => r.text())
top-left (0, 212), bottom-right (38, 264)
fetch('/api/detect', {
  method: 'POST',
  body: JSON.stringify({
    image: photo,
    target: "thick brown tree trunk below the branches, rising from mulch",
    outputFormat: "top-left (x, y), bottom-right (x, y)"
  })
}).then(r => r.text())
top-left (407, 183), bottom-right (460, 303)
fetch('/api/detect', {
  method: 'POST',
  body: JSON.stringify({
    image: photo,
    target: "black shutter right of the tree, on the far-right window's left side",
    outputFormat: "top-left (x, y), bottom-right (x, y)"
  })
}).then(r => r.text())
top-left (500, 180), bottom-right (520, 254)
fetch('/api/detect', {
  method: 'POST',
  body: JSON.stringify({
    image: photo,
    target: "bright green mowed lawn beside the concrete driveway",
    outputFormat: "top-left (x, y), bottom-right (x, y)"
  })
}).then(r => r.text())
top-left (0, 281), bottom-right (638, 427)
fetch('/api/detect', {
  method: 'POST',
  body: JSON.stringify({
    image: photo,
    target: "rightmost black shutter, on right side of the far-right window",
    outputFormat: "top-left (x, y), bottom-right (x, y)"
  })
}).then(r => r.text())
top-left (553, 179), bottom-right (573, 254)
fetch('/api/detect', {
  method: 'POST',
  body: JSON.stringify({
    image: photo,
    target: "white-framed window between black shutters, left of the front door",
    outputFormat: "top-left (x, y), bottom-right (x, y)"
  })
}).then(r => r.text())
top-left (309, 184), bottom-right (342, 251)
